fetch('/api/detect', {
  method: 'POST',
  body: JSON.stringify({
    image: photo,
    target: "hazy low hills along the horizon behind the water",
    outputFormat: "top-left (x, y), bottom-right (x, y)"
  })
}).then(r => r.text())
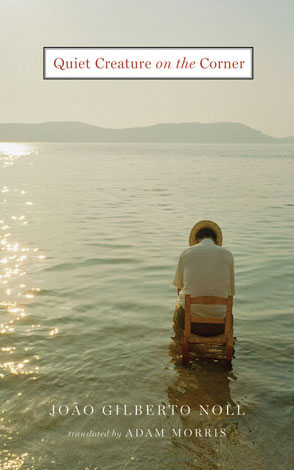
top-left (0, 121), bottom-right (294, 144)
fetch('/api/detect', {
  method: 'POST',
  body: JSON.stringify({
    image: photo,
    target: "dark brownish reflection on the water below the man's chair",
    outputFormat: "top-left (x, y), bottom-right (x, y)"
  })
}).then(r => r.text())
top-left (166, 337), bottom-right (246, 470)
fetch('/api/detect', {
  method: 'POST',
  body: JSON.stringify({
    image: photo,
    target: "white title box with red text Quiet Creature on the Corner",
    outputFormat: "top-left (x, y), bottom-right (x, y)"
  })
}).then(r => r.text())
top-left (43, 47), bottom-right (253, 80)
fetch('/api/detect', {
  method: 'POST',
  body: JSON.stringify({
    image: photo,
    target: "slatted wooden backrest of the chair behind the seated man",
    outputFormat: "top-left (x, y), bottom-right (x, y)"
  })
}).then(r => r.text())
top-left (185, 294), bottom-right (233, 336)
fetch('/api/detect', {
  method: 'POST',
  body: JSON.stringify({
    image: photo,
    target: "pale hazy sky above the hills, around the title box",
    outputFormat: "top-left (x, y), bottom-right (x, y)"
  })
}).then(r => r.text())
top-left (0, 0), bottom-right (294, 137)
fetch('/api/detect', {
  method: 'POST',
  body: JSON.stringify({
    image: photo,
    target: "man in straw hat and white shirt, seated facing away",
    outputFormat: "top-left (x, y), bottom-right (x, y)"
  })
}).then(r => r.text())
top-left (173, 220), bottom-right (235, 336)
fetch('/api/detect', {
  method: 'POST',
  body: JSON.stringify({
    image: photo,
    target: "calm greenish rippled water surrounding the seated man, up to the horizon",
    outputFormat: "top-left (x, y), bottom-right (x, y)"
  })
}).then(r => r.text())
top-left (0, 143), bottom-right (294, 470)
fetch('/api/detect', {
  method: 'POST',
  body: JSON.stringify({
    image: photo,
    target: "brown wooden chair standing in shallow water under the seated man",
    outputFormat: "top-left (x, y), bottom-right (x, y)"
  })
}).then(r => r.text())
top-left (182, 294), bottom-right (234, 364)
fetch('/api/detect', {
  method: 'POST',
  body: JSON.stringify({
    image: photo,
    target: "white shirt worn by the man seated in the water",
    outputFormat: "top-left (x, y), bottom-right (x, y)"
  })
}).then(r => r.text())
top-left (173, 238), bottom-right (235, 317)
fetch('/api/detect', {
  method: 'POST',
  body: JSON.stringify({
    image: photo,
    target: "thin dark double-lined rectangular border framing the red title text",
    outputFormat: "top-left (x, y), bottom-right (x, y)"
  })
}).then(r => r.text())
top-left (43, 46), bottom-right (254, 80)
